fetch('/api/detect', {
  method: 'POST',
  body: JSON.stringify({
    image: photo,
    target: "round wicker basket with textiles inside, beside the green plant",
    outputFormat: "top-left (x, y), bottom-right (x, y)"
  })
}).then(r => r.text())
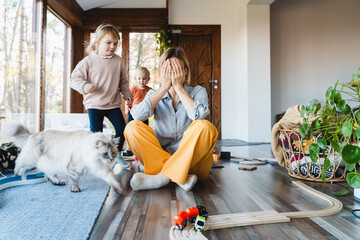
top-left (279, 127), bottom-right (346, 182)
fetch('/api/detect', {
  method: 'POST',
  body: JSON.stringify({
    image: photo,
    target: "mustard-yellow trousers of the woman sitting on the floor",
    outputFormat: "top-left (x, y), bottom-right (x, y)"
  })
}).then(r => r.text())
top-left (124, 120), bottom-right (218, 184)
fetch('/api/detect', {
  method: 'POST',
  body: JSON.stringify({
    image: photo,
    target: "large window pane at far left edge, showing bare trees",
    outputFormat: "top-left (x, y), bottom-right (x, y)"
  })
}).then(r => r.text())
top-left (0, 0), bottom-right (38, 131)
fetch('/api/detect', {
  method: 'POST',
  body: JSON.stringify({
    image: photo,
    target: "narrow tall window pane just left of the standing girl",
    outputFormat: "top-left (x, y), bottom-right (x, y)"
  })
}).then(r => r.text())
top-left (45, 11), bottom-right (66, 113)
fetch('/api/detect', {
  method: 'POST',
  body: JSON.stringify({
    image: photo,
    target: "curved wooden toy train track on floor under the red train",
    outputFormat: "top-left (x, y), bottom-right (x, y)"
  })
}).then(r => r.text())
top-left (169, 181), bottom-right (343, 240)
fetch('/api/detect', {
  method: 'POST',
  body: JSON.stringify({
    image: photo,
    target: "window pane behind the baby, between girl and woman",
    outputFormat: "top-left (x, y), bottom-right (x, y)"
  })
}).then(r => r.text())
top-left (129, 33), bottom-right (160, 89)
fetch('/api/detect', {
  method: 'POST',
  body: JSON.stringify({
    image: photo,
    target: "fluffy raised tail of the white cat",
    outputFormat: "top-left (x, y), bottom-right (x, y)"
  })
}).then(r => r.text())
top-left (1, 122), bottom-right (30, 148)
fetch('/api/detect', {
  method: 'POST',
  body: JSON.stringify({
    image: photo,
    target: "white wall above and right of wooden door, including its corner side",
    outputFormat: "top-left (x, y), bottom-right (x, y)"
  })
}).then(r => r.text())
top-left (169, 0), bottom-right (271, 142)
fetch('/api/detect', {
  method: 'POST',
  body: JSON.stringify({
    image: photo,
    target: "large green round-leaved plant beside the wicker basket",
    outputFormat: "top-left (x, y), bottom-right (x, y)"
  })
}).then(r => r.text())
top-left (299, 68), bottom-right (360, 200)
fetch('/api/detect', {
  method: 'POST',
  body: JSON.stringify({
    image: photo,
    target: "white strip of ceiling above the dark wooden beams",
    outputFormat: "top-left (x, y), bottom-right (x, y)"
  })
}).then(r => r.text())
top-left (76, 0), bottom-right (166, 11)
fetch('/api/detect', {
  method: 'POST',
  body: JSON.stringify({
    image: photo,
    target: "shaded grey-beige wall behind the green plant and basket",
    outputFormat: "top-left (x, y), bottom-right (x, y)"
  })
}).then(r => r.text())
top-left (270, 0), bottom-right (360, 125)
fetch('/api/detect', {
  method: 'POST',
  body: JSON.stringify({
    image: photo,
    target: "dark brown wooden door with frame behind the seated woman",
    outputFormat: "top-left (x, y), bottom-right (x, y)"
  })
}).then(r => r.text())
top-left (169, 25), bottom-right (221, 139)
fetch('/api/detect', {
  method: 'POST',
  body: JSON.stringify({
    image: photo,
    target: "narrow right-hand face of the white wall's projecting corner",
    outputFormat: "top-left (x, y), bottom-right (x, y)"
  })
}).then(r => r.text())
top-left (247, 5), bottom-right (271, 142)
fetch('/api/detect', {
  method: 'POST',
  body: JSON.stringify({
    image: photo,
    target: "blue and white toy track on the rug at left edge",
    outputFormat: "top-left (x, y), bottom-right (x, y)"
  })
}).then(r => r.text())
top-left (0, 173), bottom-right (46, 191)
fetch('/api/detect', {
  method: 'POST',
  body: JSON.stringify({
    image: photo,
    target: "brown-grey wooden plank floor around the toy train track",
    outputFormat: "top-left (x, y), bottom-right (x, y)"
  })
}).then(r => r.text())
top-left (90, 144), bottom-right (360, 240)
